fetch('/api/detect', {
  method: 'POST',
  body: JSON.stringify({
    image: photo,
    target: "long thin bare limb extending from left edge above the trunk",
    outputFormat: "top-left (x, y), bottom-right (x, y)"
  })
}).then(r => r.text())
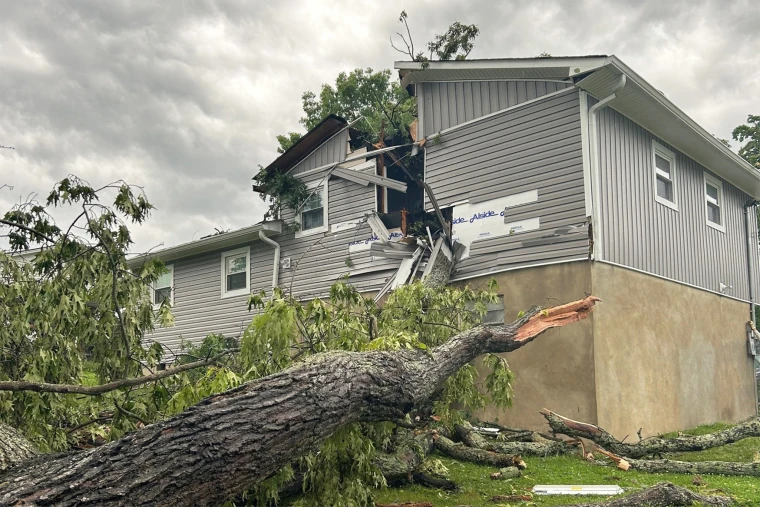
top-left (0, 349), bottom-right (240, 396)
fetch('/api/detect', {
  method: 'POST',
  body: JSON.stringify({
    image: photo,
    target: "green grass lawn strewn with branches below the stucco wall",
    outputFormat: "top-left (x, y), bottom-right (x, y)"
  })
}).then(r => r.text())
top-left (375, 424), bottom-right (760, 507)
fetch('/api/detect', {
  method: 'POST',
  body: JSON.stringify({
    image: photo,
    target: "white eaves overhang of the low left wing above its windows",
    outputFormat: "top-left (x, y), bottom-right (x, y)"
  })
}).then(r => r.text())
top-left (127, 220), bottom-right (282, 268)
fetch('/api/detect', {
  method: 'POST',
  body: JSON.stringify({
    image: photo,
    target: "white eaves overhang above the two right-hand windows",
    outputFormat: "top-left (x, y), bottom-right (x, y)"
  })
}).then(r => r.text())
top-left (576, 56), bottom-right (760, 198)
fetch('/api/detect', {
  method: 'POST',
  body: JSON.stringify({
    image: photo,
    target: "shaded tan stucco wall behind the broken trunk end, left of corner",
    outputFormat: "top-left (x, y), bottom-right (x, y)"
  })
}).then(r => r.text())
top-left (457, 261), bottom-right (596, 430)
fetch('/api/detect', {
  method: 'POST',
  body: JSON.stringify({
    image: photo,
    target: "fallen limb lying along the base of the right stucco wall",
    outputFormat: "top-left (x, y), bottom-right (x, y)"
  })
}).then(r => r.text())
top-left (541, 409), bottom-right (760, 458)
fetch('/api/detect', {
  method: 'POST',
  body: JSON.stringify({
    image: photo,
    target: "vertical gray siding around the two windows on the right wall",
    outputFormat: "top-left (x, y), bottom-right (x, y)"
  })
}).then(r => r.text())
top-left (589, 103), bottom-right (759, 300)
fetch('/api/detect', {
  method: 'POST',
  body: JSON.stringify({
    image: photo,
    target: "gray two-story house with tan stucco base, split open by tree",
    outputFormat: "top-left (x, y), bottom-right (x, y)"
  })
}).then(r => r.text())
top-left (134, 56), bottom-right (760, 437)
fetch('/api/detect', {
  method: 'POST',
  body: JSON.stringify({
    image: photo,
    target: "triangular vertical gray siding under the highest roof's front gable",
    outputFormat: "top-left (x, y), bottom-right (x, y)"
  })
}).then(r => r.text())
top-left (418, 81), bottom-right (572, 136)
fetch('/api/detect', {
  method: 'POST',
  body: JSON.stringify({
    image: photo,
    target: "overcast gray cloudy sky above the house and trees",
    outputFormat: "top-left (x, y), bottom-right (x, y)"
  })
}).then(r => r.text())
top-left (0, 0), bottom-right (760, 251)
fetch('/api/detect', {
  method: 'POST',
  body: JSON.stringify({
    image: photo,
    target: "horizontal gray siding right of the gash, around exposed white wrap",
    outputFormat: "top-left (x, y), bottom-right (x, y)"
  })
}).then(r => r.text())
top-left (425, 91), bottom-right (589, 279)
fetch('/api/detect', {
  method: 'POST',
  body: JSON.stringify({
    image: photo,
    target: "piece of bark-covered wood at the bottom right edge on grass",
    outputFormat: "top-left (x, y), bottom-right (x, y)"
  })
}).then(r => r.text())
top-left (552, 482), bottom-right (734, 507)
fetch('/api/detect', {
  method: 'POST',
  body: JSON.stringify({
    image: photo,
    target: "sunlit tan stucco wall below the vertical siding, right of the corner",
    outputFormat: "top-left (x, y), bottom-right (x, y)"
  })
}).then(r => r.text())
top-left (592, 263), bottom-right (755, 438)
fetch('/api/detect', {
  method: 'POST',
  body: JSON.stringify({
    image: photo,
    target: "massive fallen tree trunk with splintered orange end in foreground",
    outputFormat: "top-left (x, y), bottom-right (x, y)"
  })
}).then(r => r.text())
top-left (0, 297), bottom-right (598, 506)
